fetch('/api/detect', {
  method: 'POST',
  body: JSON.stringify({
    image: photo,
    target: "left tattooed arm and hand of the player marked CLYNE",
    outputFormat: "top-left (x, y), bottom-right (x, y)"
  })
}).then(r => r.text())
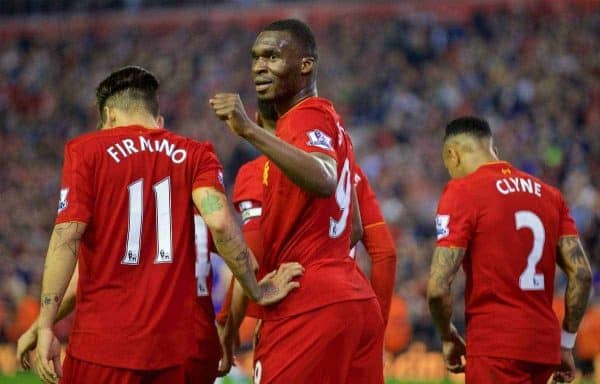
top-left (427, 247), bottom-right (465, 373)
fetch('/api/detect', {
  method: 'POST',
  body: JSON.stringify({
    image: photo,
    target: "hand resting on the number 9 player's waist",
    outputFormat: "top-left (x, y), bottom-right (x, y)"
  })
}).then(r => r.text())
top-left (257, 263), bottom-right (304, 305)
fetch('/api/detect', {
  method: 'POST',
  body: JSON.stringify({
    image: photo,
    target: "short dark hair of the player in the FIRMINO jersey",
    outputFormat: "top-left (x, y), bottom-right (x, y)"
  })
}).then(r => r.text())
top-left (96, 66), bottom-right (160, 124)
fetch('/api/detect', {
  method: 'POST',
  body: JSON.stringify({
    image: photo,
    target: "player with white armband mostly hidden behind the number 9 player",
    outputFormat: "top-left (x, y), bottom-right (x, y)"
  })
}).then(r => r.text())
top-left (217, 100), bottom-right (396, 374)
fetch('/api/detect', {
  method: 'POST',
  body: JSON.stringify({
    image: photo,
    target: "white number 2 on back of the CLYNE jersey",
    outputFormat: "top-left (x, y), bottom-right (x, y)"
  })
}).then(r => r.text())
top-left (515, 211), bottom-right (546, 291)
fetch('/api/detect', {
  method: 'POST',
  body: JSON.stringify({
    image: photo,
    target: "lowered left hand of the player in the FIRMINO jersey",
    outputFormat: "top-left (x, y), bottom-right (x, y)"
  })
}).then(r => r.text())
top-left (34, 328), bottom-right (62, 384)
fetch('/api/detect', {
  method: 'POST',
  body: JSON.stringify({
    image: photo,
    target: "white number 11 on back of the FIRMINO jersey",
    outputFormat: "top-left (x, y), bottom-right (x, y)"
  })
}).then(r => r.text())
top-left (121, 177), bottom-right (173, 265)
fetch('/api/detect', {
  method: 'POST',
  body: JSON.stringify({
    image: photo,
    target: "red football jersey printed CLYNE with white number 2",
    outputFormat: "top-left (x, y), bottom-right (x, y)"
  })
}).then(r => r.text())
top-left (436, 162), bottom-right (577, 364)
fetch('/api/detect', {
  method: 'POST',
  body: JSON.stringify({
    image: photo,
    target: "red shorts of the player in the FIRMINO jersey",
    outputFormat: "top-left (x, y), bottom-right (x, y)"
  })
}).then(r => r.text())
top-left (60, 354), bottom-right (186, 384)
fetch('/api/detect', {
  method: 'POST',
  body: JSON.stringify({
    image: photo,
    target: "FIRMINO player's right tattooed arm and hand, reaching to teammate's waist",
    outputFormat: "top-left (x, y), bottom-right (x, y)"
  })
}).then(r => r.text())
top-left (192, 187), bottom-right (303, 305)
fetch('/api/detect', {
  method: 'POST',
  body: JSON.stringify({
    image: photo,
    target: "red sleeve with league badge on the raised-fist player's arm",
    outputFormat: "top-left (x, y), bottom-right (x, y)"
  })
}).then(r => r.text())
top-left (289, 108), bottom-right (339, 160)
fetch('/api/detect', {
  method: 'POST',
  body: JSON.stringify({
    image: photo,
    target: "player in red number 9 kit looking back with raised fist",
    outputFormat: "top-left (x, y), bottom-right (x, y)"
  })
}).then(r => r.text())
top-left (210, 20), bottom-right (384, 384)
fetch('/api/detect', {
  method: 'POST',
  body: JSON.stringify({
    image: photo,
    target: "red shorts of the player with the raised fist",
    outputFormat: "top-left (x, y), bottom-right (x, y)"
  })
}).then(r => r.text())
top-left (254, 298), bottom-right (384, 384)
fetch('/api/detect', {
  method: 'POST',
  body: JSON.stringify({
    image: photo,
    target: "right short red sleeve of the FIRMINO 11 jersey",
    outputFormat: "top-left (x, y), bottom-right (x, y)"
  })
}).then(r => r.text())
top-left (192, 143), bottom-right (225, 193)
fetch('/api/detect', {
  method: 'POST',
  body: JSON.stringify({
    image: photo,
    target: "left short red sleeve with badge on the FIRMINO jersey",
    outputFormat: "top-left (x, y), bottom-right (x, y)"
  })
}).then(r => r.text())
top-left (55, 143), bottom-right (94, 224)
